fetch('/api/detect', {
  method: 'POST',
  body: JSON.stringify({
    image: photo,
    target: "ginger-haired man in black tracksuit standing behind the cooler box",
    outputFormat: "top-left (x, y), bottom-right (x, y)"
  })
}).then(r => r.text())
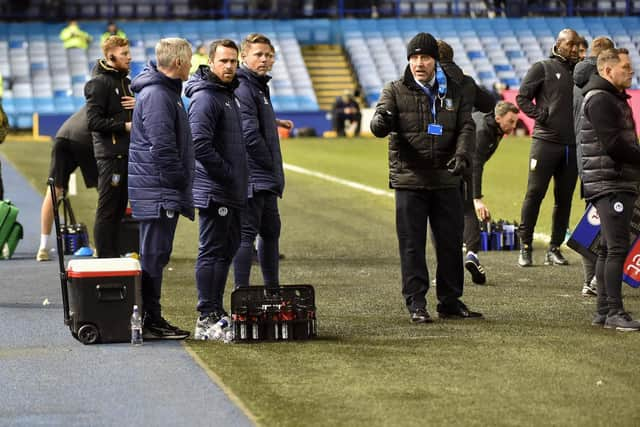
top-left (84, 36), bottom-right (135, 258)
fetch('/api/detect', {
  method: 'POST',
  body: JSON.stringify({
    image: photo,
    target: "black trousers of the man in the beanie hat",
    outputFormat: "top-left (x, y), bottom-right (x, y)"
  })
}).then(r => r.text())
top-left (396, 188), bottom-right (464, 311)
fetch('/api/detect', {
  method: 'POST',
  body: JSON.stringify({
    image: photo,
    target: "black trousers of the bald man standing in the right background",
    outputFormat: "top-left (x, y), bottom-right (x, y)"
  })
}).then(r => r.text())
top-left (518, 140), bottom-right (578, 246)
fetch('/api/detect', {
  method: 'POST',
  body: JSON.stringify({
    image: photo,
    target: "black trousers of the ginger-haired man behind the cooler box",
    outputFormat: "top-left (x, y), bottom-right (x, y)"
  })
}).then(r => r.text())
top-left (93, 157), bottom-right (128, 258)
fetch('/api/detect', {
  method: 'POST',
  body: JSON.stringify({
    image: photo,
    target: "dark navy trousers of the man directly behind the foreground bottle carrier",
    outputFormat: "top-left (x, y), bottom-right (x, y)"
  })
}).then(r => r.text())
top-left (233, 191), bottom-right (281, 288)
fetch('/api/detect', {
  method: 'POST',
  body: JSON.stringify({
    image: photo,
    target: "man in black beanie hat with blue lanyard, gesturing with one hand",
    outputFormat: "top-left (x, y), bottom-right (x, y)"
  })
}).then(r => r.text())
top-left (371, 33), bottom-right (482, 323)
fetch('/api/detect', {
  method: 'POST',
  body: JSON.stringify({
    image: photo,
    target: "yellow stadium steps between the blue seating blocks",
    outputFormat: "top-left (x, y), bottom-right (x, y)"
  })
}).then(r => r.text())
top-left (302, 44), bottom-right (358, 110)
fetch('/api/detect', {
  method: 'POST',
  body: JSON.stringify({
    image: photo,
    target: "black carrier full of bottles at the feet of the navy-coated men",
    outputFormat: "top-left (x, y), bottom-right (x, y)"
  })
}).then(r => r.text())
top-left (231, 285), bottom-right (318, 343)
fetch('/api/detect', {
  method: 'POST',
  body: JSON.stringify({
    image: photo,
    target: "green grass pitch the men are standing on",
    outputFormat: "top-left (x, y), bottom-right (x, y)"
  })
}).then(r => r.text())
top-left (0, 138), bottom-right (640, 426)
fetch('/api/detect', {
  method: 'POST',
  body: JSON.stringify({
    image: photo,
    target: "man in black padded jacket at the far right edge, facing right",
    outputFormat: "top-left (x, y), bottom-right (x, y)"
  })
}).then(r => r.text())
top-left (579, 49), bottom-right (640, 331)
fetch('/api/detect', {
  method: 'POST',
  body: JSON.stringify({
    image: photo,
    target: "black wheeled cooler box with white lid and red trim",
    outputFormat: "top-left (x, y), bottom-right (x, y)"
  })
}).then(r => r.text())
top-left (67, 258), bottom-right (142, 344)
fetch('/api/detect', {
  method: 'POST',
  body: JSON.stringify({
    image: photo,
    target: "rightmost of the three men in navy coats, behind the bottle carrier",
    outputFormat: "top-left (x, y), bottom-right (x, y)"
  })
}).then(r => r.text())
top-left (233, 33), bottom-right (293, 288)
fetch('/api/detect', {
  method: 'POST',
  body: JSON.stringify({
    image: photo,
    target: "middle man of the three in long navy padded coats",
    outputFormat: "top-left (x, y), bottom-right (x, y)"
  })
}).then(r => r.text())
top-left (185, 39), bottom-right (248, 340)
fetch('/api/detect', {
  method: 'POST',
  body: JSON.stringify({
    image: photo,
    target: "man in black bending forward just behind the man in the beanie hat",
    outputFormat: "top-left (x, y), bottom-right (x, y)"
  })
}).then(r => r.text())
top-left (464, 101), bottom-right (519, 285)
